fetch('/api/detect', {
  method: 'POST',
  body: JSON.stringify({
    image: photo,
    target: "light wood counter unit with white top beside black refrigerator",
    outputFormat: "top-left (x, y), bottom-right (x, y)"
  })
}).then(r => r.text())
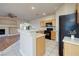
top-left (63, 37), bottom-right (79, 56)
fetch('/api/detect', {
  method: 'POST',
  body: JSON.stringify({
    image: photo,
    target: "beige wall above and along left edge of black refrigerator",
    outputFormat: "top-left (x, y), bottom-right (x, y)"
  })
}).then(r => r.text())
top-left (56, 4), bottom-right (75, 41)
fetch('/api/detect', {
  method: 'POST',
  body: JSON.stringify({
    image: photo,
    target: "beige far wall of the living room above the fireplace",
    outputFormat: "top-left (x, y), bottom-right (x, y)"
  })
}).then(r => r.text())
top-left (0, 17), bottom-right (19, 34)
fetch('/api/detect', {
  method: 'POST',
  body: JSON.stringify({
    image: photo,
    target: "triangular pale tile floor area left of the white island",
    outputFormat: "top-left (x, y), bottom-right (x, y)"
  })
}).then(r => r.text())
top-left (0, 40), bottom-right (21, 56)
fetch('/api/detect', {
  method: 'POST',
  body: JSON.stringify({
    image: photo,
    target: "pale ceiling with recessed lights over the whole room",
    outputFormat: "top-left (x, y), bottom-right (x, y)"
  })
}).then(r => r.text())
top-left (0, 3), bottom-right (62, 20)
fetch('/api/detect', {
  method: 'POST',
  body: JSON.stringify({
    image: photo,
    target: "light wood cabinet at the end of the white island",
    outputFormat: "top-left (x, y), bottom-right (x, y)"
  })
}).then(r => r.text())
top-left (36, 36), bottom-right (45, 56)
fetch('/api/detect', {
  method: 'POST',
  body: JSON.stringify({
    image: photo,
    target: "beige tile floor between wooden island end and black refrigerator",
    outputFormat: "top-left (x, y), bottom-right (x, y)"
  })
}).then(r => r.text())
top-left (45, 39), bottom-right (58, 56)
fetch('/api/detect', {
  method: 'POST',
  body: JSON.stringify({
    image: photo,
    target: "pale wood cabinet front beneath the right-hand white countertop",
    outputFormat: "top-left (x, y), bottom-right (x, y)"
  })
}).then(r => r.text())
top-left (64, 43), bottom-right (79, 56)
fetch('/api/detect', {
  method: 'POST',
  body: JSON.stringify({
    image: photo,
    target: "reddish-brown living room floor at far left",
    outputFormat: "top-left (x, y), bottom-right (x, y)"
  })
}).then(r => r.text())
top-left (0, 34), bottom-right (20, 51)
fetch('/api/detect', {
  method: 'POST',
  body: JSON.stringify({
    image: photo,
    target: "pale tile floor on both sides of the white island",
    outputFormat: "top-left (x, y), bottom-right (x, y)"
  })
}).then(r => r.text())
top-left (0, 39), bottom-right (58, 56)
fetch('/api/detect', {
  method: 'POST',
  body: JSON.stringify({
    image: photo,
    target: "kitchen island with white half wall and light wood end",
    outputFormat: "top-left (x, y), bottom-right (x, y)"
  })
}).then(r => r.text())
top-left (20, 30), bottom-right (45, 56)
